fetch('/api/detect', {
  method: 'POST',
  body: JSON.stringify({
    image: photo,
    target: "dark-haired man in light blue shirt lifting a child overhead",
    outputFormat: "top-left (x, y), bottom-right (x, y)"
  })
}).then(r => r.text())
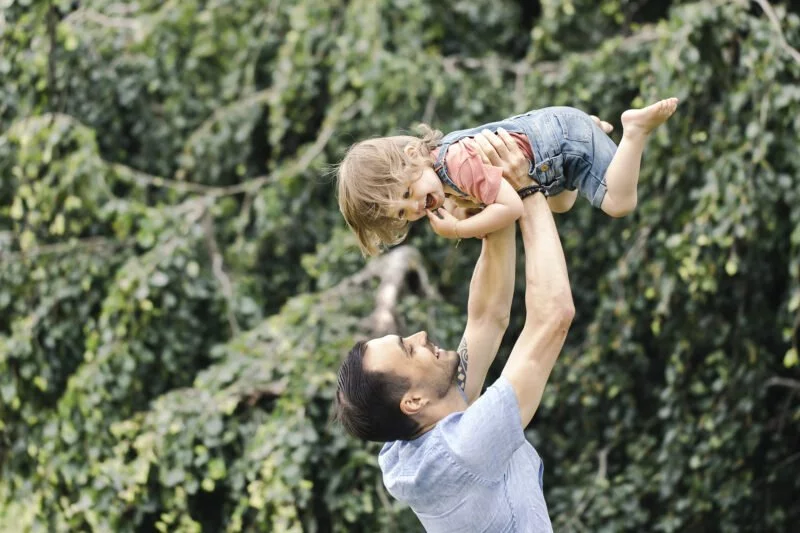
top-left (336, 123), bottom-right (610, 533)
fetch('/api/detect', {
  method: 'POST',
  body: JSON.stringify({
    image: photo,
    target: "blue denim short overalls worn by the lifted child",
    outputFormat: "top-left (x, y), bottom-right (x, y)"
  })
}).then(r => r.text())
top-left (433, 107), bottom-right (617, 207)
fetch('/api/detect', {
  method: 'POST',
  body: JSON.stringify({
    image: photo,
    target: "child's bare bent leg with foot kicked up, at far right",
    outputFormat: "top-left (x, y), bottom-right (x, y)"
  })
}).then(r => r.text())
top-left (600, 98), bottom-right (678, 217)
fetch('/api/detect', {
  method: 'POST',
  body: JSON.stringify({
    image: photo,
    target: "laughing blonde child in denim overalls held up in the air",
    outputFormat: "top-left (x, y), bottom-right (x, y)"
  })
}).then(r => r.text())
top-left (338, 98), bottom-right (678, 255)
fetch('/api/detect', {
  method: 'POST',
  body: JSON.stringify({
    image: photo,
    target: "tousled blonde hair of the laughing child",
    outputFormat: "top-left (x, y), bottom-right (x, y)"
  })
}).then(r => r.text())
top-left (337, 124), bottom-right (442, 256)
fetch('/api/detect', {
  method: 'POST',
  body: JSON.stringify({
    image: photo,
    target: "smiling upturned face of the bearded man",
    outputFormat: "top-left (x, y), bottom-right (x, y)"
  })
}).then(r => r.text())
top-left (364, 331), bottom-right (458, 401)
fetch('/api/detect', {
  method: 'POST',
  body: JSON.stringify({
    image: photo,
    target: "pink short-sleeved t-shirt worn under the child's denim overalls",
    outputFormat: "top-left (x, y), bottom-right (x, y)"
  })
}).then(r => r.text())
top-left (432, 132), bottom-right (533, 205)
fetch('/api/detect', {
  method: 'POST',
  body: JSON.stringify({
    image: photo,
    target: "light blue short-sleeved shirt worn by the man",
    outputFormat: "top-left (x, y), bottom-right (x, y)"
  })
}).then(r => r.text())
top-left (378, 377), bottom-right (553, 533)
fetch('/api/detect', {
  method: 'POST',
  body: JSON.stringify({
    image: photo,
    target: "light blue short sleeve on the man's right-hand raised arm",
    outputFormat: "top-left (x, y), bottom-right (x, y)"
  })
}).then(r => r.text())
top-left (441, 377), bottom-right (526, 481)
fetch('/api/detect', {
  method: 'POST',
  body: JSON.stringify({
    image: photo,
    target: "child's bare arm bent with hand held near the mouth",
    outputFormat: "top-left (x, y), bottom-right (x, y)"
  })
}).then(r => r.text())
top-left (428, 180), bottom-right (522, 239)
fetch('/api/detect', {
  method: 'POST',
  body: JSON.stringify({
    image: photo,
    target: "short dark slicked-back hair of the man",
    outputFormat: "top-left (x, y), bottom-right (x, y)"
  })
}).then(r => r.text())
top-left (336, 341), bottom-right (420, 442)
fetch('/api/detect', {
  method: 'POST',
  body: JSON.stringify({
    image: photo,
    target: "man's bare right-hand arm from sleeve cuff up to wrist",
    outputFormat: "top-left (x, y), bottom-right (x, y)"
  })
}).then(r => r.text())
top-left (502, 192), bottom-right (575, 427)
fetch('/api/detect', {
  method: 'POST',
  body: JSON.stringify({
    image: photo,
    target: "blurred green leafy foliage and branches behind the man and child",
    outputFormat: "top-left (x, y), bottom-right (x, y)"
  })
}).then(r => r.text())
top-left (0, 0), bottom-right (800, 533)
